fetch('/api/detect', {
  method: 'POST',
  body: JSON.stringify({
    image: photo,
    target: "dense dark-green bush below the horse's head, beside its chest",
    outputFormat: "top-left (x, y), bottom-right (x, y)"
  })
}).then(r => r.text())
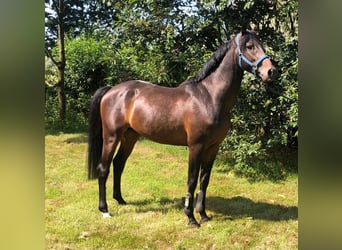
top-left (219, 56), bottom-right (298, 180)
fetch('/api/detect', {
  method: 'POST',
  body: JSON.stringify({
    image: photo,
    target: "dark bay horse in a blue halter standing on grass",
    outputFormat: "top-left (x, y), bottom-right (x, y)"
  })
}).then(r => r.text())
top-left (88, 31), bottom-right (276, 226)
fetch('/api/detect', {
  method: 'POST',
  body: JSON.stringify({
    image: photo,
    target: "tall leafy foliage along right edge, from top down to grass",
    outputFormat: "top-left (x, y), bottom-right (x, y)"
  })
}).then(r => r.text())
top-left (221, 1), bottom-right (298, 180)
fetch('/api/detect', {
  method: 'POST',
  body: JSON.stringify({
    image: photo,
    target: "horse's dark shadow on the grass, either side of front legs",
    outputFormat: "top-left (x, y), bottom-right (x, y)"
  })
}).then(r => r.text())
top-left (125, 196), bottom-right (298, 221)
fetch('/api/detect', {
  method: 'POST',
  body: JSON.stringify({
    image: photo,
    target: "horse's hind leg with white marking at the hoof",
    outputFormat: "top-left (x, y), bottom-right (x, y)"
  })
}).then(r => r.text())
top-left (97, 137), bottom-right (118, 217)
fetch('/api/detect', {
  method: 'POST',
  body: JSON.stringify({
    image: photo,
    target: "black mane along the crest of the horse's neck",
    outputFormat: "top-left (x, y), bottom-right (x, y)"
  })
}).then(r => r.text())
top-left (182, 40), bottom-right (232, 84)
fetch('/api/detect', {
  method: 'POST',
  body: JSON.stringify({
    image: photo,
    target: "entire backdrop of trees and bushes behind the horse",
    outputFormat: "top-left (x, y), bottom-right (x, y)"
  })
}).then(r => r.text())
top-left (45, 0), bottom-right (298, 180)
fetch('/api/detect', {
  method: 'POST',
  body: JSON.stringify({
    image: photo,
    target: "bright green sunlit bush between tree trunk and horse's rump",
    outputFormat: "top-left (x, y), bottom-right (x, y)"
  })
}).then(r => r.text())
top-left (65, 36), bottom-right (112, 115)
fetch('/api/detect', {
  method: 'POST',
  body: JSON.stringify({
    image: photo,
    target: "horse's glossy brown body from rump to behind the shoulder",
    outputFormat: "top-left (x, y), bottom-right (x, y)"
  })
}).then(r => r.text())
top-left (101, 81), bottom-right (188, 145)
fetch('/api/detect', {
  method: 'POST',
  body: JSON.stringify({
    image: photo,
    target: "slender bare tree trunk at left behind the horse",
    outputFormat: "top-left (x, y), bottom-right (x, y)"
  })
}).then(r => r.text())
top-left (57, 0), bottom-right (66, 120)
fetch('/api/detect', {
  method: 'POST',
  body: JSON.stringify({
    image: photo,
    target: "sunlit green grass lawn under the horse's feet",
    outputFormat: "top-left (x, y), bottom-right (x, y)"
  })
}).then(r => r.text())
top-left (45, 134), bottom-right (298, 249)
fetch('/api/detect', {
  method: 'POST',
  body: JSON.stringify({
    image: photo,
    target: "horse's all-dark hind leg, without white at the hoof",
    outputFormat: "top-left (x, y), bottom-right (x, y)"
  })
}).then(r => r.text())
top-left (113, 129), bottom-right (140, 205)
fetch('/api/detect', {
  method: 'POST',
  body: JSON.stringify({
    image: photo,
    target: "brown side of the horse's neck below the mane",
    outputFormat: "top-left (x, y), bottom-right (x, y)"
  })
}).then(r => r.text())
top-left (201, 46), bottom-right (243, 116)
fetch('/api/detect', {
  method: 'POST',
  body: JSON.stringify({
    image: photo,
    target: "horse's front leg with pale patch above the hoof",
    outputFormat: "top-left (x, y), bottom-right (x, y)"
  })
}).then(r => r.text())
top-left (184, 146), bottom-right (201, 227)
